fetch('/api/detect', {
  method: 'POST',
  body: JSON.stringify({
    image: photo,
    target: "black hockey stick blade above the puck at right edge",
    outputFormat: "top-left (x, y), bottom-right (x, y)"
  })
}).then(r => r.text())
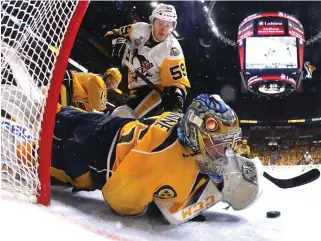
top-left (263, 169), bottom-right (320, 189)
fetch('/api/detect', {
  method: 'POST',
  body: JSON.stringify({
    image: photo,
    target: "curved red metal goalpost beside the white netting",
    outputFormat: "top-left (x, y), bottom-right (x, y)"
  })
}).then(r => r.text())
top-left (37, 0), bottom-right (89, 206)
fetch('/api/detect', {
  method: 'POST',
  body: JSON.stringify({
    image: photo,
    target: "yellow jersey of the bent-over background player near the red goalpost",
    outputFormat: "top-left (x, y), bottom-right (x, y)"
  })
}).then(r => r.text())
top-left (71, 71), bottom-right (107, 111)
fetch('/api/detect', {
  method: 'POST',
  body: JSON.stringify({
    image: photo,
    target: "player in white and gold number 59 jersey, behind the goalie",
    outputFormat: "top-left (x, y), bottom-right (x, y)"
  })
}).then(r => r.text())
top-left (105, 4), bottom-right (190, 118)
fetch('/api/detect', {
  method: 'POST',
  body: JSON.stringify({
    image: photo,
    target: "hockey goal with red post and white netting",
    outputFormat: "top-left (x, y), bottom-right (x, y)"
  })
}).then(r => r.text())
top-left (0, 0), bottom-right (89, 205)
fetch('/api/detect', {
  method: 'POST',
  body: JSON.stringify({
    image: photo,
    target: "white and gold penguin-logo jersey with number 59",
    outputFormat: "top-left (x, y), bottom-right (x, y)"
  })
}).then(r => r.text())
top-left (107, 22), bottom-right (190, 89)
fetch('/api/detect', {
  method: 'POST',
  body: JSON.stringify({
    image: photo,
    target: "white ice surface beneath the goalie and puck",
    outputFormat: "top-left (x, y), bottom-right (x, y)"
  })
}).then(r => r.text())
top-left (0, 166), bottom-right (321, 241)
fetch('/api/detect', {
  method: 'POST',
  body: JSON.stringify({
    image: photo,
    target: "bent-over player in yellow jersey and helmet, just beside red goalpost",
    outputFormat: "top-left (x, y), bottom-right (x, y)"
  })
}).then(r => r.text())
top-left (59, 68), bottom-right (122, 111)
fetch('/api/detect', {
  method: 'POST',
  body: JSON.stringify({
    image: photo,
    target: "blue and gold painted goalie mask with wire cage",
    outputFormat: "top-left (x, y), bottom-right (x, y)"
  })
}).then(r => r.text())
top-left (178, 94), bottom-right (241, 182)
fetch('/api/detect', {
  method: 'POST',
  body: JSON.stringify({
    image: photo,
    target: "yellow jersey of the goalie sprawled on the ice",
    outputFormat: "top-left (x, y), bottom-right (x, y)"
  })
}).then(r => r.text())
top-left (102, 112), bottom-right (200, 215)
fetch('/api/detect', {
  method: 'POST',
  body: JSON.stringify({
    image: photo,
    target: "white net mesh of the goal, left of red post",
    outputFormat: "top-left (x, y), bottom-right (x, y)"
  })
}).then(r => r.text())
top-left (0, 0), bottom-right (78, 202)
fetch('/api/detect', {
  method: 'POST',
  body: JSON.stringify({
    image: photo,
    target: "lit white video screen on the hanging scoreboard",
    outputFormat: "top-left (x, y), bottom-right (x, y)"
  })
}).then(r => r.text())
top-left (245, 36), bottom-right (298, 70)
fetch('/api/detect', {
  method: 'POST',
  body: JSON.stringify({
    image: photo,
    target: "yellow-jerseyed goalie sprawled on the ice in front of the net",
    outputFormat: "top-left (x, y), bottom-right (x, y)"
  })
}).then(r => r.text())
top-left (51, 94), bottom-right (262, 224)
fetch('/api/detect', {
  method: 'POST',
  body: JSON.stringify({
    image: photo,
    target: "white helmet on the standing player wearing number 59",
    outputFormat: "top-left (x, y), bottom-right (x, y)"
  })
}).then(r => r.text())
top-left (149, 3), bottom-right (177, 29)
